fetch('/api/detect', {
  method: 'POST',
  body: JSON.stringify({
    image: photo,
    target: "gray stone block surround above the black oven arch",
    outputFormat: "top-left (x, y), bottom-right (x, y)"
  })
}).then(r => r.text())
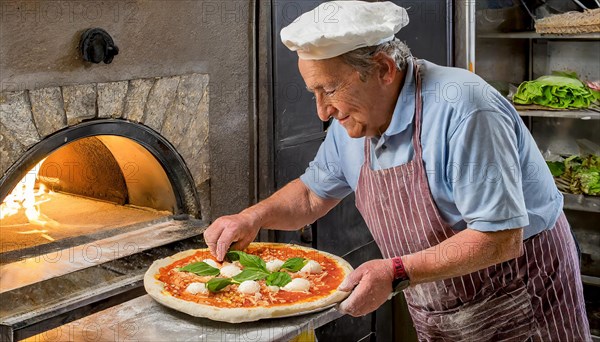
top-left (0, 74), bottom-right (210, 217)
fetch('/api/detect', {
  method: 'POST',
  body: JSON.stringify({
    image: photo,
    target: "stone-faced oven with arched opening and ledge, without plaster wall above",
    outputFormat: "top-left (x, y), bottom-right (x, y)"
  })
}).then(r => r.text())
top-left (0, 74), bottom-right (210, 339)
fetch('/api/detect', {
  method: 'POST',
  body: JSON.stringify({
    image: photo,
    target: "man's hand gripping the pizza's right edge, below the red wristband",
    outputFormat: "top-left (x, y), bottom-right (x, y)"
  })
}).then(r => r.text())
top-left (338, 259), bottom-right (394, 317)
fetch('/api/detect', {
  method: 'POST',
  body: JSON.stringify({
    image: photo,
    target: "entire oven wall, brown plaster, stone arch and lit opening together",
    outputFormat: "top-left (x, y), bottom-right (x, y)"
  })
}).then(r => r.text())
top-left (0, 0), bottom-right (256, 341)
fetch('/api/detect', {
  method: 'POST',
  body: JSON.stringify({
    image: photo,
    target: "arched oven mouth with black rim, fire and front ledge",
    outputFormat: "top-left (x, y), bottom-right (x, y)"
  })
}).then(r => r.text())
top-left (0, 119), bottom-right (203, 295)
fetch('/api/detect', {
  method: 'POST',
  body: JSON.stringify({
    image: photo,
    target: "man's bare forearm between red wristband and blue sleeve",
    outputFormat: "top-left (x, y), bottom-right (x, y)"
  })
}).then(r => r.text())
top-left (402, 228), bottom-right (523, 285)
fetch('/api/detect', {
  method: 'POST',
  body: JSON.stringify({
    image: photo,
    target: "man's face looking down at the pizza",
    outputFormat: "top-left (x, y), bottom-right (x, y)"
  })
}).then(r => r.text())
top-left (298, 57), bottom-right (392, 138)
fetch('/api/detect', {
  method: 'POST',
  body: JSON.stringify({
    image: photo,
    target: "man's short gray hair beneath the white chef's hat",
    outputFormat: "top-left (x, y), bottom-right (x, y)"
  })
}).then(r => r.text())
top-left (340, 38), bottom-right (412, 81)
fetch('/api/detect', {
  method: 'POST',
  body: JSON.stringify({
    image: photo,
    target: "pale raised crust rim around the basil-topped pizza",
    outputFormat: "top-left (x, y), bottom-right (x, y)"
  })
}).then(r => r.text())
top-left (144, 242), bottom-right (353, 323)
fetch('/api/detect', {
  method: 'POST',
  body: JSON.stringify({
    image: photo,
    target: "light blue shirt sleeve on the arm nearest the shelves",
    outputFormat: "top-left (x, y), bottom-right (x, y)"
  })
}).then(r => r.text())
top-left (446, 111), bottom-right (529, 231)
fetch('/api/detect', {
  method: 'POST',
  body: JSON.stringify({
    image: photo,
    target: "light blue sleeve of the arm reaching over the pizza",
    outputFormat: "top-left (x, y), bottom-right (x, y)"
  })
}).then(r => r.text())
top-left (300, 129), bottom-right (353, 199)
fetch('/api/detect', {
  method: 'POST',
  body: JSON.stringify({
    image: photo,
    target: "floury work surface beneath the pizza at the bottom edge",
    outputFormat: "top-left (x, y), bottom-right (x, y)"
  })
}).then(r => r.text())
top-left (28, 295), bottom-right (342, 342)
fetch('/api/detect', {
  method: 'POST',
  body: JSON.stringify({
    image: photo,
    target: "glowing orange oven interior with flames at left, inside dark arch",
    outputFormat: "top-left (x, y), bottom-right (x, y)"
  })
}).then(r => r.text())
top-left (0, 135), bottom-right (176, 252)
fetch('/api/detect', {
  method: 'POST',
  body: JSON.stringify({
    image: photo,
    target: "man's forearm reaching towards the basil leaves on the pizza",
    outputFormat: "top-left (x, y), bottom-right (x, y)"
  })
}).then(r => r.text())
top-left (241, 179), bottom-right (340, 230)
